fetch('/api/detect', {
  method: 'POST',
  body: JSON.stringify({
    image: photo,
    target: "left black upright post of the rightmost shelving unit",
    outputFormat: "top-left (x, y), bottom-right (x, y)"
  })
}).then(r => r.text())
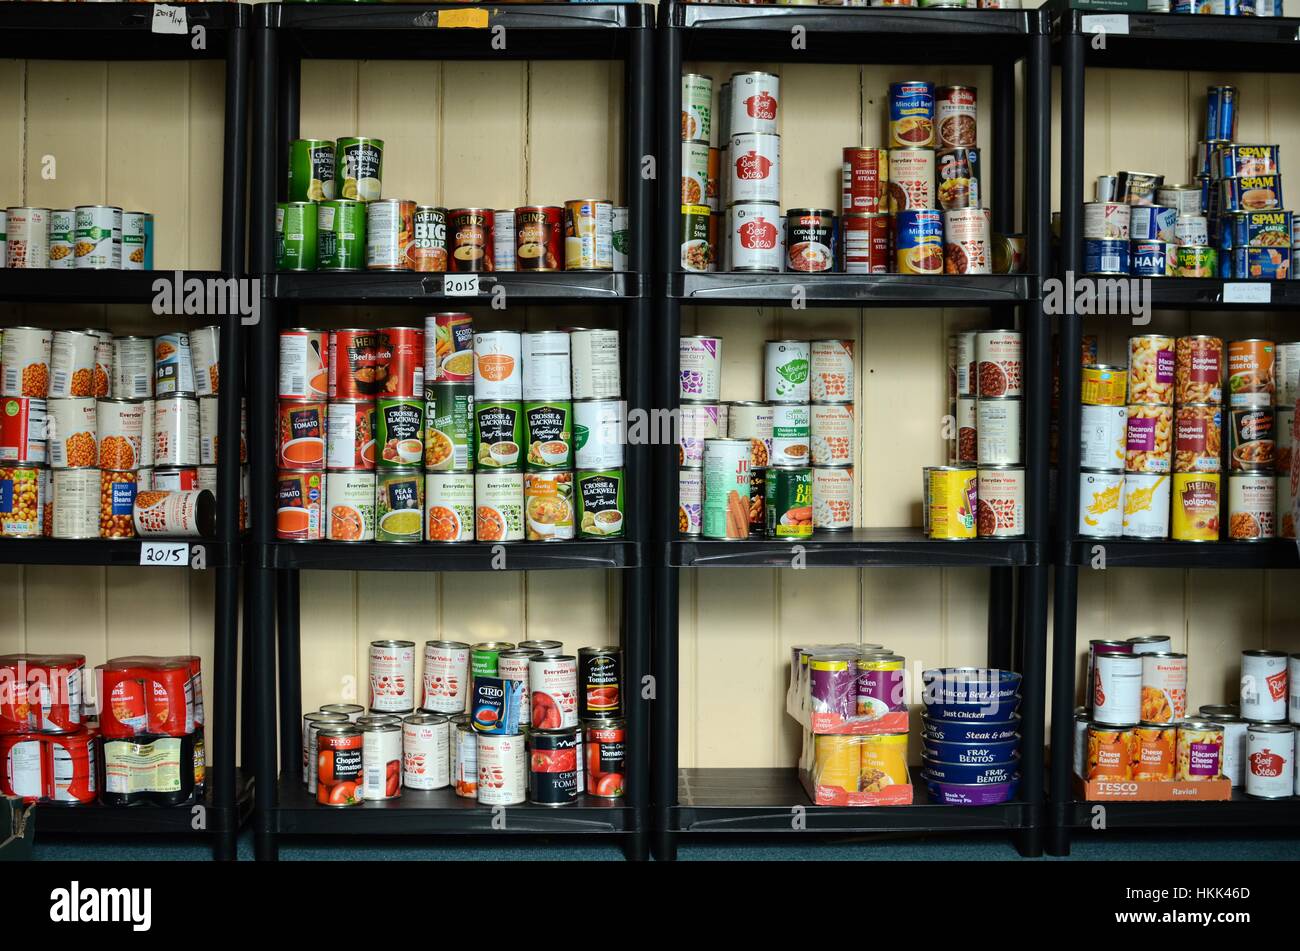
top-left (1044, 10), bottom-right (1086, 855)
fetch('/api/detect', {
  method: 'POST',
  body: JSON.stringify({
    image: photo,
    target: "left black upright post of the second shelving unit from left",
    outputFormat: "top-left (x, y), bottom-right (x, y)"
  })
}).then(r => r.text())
top-left (246, 4), bottom-right (281, 860)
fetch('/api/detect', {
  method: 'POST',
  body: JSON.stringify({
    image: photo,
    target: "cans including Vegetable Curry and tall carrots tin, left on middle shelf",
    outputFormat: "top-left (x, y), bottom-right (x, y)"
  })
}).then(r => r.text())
top-left (677, 336), bottom-right (855, 540)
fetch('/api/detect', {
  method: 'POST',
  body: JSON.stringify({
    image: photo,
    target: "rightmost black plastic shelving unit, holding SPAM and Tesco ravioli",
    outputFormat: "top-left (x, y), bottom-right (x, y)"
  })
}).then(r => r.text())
top-left (1048, 10), bottom-right (1300, 855)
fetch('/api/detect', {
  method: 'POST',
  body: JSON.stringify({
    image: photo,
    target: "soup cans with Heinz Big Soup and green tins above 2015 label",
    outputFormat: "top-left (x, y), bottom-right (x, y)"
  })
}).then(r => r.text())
top-left (276, 136), bottom-right (629, 273)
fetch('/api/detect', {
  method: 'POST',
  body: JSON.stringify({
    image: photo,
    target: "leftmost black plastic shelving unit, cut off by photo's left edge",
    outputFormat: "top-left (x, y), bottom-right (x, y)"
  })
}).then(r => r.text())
top-left (0, 3), bottom-right (251, 860)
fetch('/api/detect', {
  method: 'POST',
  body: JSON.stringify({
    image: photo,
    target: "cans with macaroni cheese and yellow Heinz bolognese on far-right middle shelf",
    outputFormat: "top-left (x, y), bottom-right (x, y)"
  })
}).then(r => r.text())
top-left (1079, 334), bottom-right (1300, 542)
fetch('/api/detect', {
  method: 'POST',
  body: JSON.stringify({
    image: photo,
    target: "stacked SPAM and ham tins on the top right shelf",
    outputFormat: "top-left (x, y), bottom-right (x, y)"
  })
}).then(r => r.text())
top-left (1083, 86), bottom-right (1300, 281)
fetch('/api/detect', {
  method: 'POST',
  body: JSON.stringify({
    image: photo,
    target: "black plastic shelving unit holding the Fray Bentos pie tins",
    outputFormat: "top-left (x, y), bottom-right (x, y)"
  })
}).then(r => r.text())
top-left (653, 0), bottom-right (1052, 859)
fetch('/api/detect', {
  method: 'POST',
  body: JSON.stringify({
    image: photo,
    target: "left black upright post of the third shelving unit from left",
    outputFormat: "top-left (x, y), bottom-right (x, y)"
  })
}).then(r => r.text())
top-left (647, 1), bottom-right (683, 861)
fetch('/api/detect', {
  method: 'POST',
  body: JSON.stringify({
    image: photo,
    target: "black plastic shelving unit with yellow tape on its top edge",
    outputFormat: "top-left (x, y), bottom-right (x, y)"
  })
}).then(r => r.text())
top-left (247, 4), bottom-right (654, 860)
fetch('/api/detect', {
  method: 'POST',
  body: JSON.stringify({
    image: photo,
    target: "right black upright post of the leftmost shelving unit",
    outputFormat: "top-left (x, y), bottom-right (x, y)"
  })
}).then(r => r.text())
top-left (209, 12), bottom-right (251, 861)
